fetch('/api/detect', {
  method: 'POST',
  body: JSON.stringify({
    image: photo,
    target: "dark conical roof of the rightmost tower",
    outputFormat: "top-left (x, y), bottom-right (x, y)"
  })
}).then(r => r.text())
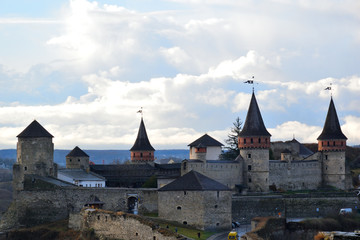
top-left (317, 97), bottom-right (347, 140)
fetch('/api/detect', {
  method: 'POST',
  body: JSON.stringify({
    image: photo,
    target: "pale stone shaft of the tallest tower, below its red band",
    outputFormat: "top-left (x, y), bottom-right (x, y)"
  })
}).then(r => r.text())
top-left (240, 148), bottom-right (269, 192)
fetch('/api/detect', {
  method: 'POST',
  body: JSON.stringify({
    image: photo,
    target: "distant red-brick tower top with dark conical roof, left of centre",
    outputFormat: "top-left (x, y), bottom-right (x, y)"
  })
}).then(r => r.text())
top-left (130, 117), bottom-right (155, 163)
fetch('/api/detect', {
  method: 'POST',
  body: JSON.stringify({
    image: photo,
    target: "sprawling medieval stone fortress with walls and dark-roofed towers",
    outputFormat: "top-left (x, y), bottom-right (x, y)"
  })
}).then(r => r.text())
top-left (1, 93), bottom-right (357, 239)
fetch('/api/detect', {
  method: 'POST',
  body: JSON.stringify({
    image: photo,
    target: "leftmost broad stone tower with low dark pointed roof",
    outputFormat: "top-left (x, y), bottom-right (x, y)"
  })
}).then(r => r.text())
top-left (13, 120), bottom-right (57, 190)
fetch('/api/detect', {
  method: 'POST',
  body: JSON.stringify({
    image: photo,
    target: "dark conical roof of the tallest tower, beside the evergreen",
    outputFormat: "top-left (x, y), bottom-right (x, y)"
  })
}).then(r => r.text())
top-left (239, 93), bottom-right (271, 137)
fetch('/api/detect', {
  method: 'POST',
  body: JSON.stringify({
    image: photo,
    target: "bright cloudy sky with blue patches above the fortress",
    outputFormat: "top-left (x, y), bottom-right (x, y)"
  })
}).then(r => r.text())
top-left (0, 0), bottom-right (360, 149)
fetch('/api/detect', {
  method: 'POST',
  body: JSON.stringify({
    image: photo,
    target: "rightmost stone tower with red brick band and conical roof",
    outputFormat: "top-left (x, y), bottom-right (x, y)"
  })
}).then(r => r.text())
top-left (317, 97), bottom-right (347, 189)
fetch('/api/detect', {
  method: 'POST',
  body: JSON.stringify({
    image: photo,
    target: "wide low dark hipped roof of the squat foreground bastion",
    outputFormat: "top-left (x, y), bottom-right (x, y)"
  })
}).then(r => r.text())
top-left (158, 171), bottom-right (230, 191)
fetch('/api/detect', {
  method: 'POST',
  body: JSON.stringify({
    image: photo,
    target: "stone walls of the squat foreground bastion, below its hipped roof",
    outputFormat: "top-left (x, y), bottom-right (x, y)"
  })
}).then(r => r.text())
top-left (158, 191), bottom-right (231, 230)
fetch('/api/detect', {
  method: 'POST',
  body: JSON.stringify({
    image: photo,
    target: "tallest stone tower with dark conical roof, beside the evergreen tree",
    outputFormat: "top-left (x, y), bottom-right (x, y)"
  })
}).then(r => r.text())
top-left (238, 92), bottom-right (271, 192)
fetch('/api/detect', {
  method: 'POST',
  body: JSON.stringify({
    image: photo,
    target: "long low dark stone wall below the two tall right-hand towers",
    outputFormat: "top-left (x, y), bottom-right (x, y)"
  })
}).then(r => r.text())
top-left (232, 193), bottom-right (359, 223)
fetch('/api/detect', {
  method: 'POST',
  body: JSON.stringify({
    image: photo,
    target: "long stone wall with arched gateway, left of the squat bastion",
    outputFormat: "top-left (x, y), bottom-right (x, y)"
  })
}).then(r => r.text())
top-left (0, 187), bottom-right (158, 227)
